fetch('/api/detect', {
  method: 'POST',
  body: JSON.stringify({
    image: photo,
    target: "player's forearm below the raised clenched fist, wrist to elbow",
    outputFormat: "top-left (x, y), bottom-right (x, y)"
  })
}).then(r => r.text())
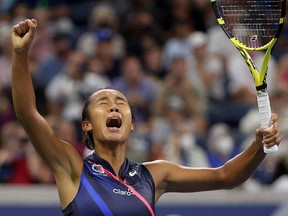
top-left (12, 51), bottom-right (36, 119)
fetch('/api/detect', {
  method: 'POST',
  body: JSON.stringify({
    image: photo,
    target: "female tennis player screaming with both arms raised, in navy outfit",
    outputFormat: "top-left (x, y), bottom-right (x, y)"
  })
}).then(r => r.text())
top-left (12, 19), bottom-right (282, 216)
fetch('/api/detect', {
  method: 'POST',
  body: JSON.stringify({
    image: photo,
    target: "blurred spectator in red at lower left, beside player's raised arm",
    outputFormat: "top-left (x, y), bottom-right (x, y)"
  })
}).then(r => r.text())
top-left (0, 121), bottom-right (54, 184)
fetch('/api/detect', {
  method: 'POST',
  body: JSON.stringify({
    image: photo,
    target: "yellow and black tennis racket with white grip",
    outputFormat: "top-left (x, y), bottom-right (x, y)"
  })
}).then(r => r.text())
top-left (211, 0), bottom-right (286, 153)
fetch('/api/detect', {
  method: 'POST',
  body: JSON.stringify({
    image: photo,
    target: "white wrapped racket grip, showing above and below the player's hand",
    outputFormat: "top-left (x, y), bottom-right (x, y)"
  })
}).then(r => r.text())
top-left (257, 92), bottom-right (278, 154)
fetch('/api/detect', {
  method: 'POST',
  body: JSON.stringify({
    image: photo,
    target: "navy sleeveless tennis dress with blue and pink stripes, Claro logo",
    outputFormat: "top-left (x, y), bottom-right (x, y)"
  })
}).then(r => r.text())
top-left (63, 154), bottom-right (155, 216)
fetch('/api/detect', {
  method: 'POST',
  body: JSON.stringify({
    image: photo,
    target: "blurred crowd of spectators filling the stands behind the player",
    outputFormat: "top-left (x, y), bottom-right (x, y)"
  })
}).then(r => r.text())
top-left (0, 0), bottom-right (288, 190)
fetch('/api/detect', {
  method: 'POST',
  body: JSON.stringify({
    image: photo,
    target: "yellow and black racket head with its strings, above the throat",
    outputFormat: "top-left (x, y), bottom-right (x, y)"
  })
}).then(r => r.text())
top-left (211, 0), bottom-right (286, 50)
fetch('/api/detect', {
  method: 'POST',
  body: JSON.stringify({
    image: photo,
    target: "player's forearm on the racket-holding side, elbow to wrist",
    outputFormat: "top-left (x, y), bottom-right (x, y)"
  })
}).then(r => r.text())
top-left (222, 141), bottom-right (266, 188)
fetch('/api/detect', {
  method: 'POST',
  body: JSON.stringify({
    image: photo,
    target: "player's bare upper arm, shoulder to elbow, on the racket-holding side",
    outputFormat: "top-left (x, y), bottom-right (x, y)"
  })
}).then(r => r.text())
top-left (144, 160), bottom-right (223, 198)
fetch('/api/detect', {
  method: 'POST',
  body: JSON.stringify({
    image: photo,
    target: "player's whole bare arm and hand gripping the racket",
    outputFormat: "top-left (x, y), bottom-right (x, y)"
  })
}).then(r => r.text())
top-left (145, 114), bottom-right (282, 200)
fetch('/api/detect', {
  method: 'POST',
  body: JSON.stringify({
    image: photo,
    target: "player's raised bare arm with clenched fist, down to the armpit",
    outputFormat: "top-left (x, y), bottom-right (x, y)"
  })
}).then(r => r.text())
top-left (11, 19), bottom-right (83, 207)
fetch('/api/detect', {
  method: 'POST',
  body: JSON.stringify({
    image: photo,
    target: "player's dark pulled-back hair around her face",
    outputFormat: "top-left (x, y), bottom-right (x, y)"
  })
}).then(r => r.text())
top-left (82, 88), bottom-right (135, 150)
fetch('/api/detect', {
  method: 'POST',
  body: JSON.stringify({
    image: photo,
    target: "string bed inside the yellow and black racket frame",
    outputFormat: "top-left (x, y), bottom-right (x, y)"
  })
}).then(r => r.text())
top-left (216, 0), bottom-right (282, 48)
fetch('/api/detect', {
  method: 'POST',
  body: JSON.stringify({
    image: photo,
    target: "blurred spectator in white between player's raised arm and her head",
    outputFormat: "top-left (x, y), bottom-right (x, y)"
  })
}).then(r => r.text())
top-left (46, 50), bottom-right (87, 121)
